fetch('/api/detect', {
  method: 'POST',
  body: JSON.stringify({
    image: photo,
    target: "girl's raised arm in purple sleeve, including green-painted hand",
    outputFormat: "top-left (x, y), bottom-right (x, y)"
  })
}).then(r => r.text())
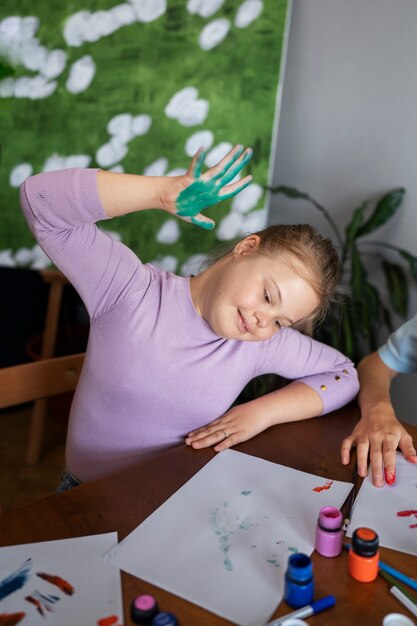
top-left (21, 146), bottom-right (252, 318)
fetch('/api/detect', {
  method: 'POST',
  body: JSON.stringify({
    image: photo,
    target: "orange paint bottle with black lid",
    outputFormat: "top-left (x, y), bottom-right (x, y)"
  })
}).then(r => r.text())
top-left (349, 527), bottom-right (379, 583)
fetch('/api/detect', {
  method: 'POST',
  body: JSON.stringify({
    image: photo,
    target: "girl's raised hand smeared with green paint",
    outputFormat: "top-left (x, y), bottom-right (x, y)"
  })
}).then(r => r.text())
top-left (165, 145), bottom-right (253, 230)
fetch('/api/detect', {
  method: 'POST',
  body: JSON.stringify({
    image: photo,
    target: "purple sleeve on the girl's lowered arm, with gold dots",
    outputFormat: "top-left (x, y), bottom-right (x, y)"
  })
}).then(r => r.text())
top-left (258, 328), bottom-right (359, 414)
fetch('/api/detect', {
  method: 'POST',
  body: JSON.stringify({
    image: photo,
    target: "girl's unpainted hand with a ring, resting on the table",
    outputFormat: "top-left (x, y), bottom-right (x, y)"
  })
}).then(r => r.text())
top-left (185, 404), bottom-right (271, 452)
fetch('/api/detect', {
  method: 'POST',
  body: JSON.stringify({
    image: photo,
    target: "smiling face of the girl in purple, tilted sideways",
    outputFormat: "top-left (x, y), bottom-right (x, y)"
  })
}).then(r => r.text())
top-left (191, 235), bottom-right (319, 341)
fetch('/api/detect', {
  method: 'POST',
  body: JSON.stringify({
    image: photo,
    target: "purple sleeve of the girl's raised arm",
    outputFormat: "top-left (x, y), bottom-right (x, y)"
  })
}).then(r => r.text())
top-left (20, 169), bottom-right (150, 318)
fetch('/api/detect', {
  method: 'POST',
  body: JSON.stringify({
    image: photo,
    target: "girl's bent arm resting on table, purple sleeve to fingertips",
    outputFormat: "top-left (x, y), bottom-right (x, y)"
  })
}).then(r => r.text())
top-left (185, 329), bottom-right (358, 451)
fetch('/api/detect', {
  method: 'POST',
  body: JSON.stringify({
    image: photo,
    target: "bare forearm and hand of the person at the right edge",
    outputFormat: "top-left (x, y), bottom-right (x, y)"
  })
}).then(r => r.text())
top-left (341, 352), bottom-right (417, 487)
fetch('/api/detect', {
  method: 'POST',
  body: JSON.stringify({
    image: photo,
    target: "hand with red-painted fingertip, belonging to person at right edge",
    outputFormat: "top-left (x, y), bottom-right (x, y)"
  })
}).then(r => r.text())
top-left (341, 405), bottom-right (417, 487)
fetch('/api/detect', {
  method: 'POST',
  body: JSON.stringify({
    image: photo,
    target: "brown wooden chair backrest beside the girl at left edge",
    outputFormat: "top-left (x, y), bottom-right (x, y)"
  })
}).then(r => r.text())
top-left (0, 352), bottom-right (85, 511)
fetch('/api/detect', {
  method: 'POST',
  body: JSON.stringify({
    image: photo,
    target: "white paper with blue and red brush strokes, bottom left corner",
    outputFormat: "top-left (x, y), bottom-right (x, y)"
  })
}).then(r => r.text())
top-left (0, 532), bottom-right (123, 626)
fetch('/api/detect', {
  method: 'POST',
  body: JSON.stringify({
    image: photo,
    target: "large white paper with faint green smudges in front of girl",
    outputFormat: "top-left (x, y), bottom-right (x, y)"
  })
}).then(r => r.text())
top-left (104, 450), bottom-right (352, 626)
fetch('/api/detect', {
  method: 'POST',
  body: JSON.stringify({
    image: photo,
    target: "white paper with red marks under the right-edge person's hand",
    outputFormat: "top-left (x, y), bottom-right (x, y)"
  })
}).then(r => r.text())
top-left (346, 453), bottom-right (417, 556)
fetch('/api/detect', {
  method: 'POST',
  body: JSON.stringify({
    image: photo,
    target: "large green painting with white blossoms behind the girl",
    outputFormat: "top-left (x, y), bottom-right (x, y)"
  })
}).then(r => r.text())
top-left (0, 0), bottom-right (287, 273)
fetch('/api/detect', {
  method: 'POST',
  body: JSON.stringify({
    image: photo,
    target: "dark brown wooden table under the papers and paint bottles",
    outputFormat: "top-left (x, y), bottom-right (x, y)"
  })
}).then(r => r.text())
top-left (0, 405), bottom-right (417, 626)
